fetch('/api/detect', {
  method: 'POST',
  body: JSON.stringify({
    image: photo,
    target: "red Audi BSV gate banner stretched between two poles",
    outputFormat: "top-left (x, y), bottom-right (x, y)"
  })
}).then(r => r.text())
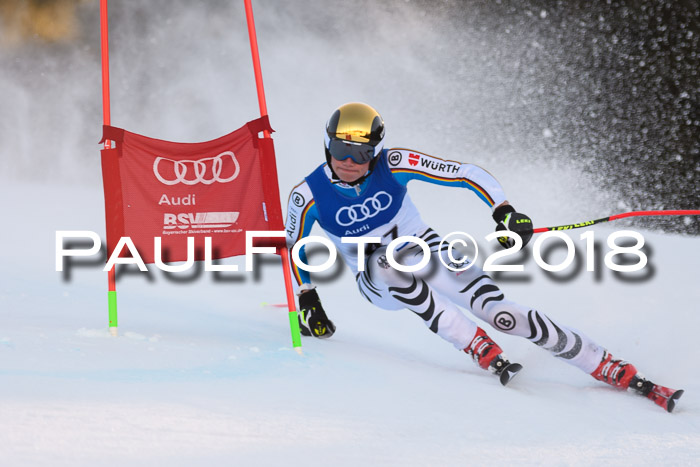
top-left (102, 117), bottom-right (283, 263)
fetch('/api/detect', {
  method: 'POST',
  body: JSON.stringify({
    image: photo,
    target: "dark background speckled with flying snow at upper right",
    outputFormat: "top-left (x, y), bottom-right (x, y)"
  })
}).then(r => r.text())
top-left (440, 0), bottom-right (700, 235)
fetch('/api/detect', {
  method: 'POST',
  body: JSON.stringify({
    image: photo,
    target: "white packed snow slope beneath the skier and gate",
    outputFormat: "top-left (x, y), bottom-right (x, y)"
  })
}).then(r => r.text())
top-left (0, 182), bottom-right (700, 466)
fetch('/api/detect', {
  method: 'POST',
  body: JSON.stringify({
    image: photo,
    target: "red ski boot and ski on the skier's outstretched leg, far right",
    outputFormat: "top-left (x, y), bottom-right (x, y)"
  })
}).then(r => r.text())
top-left (591, 350), bottom-right (683, 412)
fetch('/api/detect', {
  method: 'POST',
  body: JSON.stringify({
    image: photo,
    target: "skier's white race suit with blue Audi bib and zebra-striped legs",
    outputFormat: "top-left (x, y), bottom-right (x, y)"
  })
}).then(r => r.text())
top-left (285, 149), bottom-right (604, 373)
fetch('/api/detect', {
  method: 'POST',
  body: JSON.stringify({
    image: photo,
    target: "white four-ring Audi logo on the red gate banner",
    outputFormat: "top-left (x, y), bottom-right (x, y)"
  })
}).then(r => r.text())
top-left (153, 151), bottom-right (241, 185)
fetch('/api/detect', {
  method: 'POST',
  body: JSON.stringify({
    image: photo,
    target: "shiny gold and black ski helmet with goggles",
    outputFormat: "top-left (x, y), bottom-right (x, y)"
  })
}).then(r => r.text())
top-left (325, 102), bottom-right (384, 166)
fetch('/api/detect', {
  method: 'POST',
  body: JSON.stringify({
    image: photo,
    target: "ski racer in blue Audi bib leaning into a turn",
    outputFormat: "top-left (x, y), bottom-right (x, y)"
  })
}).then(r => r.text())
top-left (285, 102), bottom-right (683, 412)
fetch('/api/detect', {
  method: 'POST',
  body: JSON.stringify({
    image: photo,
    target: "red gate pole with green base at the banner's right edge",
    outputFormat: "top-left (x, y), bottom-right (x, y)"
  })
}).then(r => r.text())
top-left (244, 0), bottom-right (301, 354)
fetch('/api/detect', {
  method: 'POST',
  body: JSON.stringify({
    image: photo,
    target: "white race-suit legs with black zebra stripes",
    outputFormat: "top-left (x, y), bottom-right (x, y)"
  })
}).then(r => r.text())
top-left (357, 229), bottom-right (603, 373)
